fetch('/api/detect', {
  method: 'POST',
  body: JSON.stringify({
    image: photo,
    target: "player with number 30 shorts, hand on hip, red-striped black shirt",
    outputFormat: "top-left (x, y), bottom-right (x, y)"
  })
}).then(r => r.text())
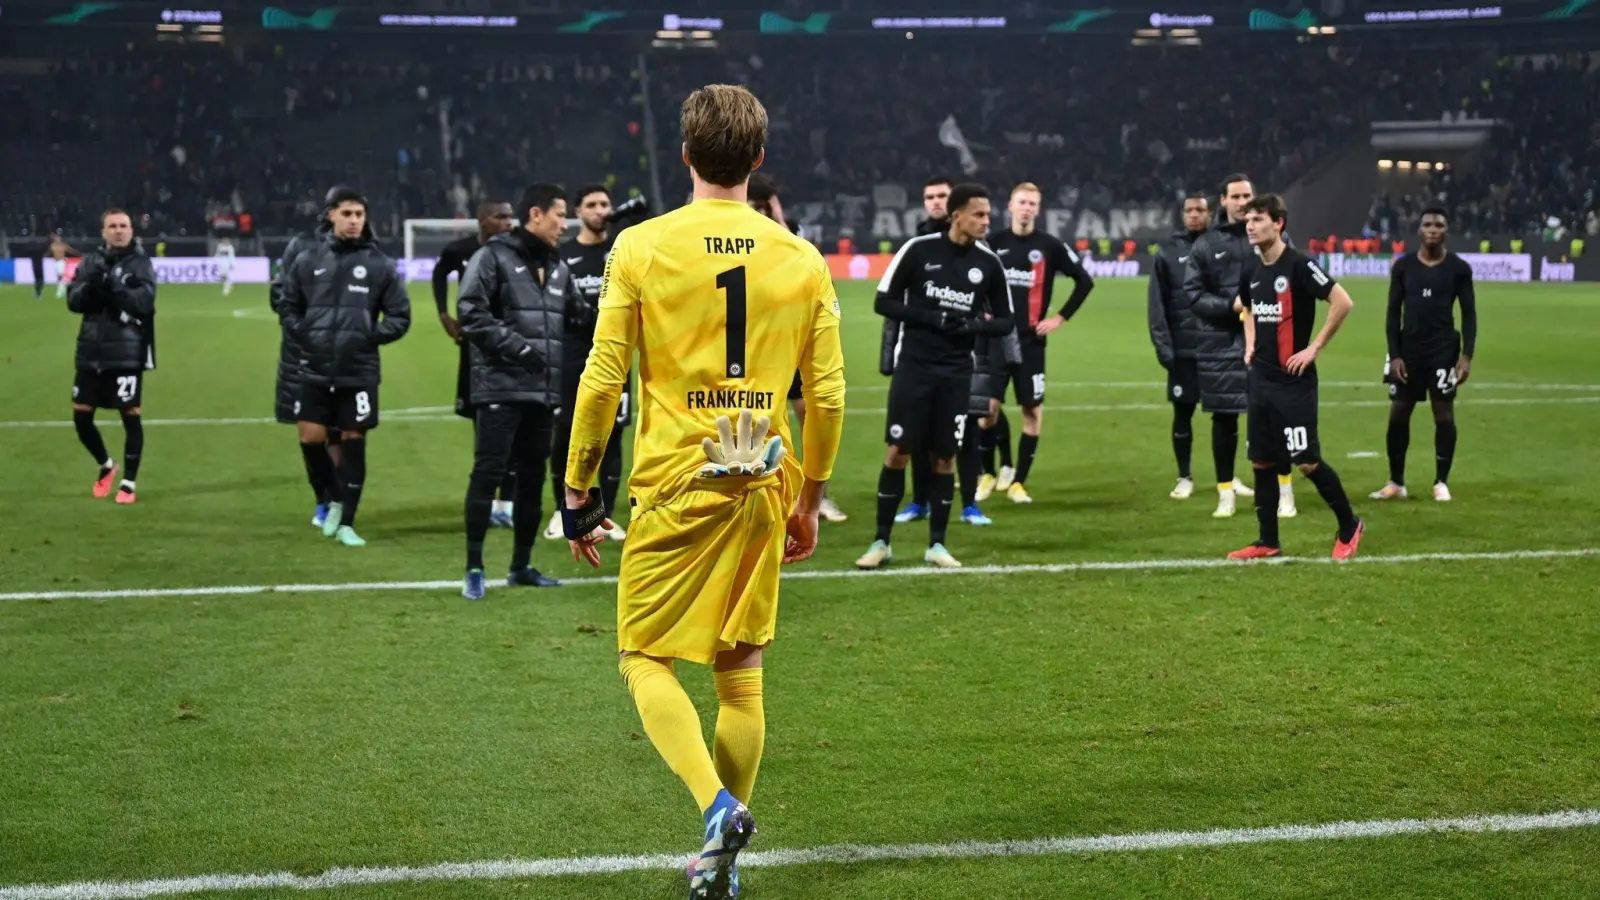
top-left (1229, 194), bottom-right (1363, 560)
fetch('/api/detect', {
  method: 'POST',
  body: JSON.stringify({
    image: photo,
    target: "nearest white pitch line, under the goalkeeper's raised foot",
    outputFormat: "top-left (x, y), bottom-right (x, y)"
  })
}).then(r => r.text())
top-left (0, 809), bottom-right (1600, 900)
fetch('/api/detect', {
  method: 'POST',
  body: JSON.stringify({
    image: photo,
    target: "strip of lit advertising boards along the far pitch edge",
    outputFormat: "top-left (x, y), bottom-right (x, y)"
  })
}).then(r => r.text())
top-left (0, 253), bottom-right (1574, 285)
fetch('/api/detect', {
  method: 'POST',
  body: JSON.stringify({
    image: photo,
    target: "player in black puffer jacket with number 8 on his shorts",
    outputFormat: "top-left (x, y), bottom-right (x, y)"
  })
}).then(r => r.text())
top-left (278, 187), bottom-right (411, 546)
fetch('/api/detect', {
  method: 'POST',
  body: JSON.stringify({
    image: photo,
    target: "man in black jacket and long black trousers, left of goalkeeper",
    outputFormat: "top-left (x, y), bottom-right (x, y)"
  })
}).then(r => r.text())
top-left (456, 183), bottom-right (582, 601)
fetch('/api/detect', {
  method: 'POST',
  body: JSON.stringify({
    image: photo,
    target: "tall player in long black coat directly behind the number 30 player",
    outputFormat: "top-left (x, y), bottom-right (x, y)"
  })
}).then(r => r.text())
top-left (1182, 173), bottom-right (1294, 519)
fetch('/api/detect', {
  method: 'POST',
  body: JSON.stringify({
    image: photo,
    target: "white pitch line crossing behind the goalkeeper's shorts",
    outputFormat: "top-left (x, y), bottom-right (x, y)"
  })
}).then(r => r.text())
top-left (0, 548), bottom-right (1600, 601)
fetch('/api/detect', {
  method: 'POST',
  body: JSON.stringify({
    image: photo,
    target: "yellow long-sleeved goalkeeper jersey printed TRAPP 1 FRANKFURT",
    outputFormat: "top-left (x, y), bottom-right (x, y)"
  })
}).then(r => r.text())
top-left (566, 200), bottom-right (845, 509)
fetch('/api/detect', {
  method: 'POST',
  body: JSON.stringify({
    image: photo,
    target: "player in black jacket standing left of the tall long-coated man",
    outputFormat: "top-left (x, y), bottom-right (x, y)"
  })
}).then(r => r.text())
top-left (1149, 194), bottom-right (1211, 500)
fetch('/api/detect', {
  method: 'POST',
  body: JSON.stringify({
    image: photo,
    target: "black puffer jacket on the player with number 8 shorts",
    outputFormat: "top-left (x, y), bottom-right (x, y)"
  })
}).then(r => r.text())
top-left (278, 235), bottom-right (411, 388)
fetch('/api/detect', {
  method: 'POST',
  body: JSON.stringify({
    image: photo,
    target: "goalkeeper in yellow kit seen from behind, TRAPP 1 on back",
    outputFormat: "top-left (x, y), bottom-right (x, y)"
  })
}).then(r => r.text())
top-left (563, 85), bottom-right (845, 900)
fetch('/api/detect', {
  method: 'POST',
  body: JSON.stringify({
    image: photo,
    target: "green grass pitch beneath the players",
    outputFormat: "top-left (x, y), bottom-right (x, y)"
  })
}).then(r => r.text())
top-left (0, 280), bottom-right (1600, 900)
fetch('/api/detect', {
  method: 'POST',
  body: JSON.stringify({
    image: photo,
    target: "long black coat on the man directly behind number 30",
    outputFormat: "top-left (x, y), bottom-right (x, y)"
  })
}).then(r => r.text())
top-left (1184, 221), bottom-right (1256, 413)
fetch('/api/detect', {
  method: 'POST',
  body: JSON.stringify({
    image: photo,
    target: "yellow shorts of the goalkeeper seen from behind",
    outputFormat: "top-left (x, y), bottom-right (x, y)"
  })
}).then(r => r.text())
top-left (616, 458), bottom-right (800, 663)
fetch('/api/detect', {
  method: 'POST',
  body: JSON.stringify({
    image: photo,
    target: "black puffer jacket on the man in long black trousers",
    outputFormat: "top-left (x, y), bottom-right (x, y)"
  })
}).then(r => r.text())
top-left (456, 227), bottom-right (584, 410)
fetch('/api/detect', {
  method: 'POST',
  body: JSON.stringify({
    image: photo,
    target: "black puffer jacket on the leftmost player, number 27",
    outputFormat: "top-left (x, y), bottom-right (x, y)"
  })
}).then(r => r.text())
top-left (67, 247), bottom-right (155, 372)
